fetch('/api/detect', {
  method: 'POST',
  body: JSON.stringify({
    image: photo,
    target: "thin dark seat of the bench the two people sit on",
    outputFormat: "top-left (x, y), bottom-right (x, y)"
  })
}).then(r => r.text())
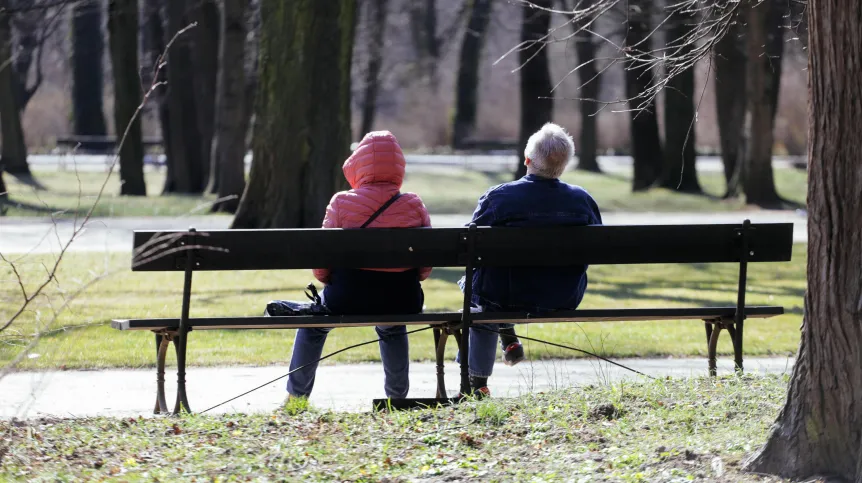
top-left (111, 306), bottom-right (784, 330)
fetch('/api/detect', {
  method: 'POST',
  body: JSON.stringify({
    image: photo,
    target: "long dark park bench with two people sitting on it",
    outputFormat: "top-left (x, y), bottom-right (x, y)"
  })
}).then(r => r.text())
top-left (112, 220), bottom-right (793, 413)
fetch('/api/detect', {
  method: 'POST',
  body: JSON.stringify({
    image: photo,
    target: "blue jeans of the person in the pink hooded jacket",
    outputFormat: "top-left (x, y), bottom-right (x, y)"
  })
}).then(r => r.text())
top-left (287, 325), bottom-right (410, 398)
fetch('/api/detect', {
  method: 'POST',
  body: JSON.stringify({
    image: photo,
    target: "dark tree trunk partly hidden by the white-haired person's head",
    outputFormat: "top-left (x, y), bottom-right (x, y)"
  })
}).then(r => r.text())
top-left (515, 0), bottom-right (554, 179)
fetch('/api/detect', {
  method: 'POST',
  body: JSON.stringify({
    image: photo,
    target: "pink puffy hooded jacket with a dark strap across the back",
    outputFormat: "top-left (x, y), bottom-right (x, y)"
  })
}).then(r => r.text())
top-left (314, 131), bottom-right (431, 283)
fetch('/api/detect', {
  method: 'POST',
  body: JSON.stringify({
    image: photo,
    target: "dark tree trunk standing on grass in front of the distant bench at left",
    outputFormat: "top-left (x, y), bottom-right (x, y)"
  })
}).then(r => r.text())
top-left (108, 0), bottom-right (147, 196)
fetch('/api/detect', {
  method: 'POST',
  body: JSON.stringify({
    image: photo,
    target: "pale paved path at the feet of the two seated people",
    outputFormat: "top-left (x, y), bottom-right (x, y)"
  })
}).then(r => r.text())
top-left (0, 357), bottom-right (793, 419)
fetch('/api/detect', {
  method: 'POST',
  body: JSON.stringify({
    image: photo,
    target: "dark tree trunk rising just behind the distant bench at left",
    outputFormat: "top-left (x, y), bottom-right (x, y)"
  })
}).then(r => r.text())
top-left (72, 1), bottom-right (107, 136)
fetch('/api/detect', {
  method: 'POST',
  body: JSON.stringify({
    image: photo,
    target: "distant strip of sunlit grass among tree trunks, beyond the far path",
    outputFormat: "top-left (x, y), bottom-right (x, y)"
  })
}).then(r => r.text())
top-left (5, 169), bottom-right (806, 216)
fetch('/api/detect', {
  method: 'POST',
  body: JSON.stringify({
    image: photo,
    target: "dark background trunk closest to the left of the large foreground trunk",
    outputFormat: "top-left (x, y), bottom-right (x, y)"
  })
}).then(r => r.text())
top-left (742, 0), bottom-right (783, 207)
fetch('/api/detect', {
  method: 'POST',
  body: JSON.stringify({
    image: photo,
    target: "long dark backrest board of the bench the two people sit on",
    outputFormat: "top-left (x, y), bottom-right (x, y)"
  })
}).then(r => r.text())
top-left (132, 223), bottom-right (793, 271)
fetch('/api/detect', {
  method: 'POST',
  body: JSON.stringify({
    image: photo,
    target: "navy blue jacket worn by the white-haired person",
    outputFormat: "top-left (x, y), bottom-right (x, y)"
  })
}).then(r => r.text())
top-left (472, 174), bottom-right (602, 312)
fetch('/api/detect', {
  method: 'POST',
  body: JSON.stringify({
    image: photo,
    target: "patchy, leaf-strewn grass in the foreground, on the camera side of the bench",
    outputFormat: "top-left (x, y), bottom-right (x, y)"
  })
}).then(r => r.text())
top-left (0, 376), bottom-right (787, 482)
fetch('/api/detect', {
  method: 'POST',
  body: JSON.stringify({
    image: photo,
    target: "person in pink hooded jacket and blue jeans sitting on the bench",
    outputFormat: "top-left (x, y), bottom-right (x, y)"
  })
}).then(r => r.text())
top-left (287, 131), bottom-right (431, 398)
